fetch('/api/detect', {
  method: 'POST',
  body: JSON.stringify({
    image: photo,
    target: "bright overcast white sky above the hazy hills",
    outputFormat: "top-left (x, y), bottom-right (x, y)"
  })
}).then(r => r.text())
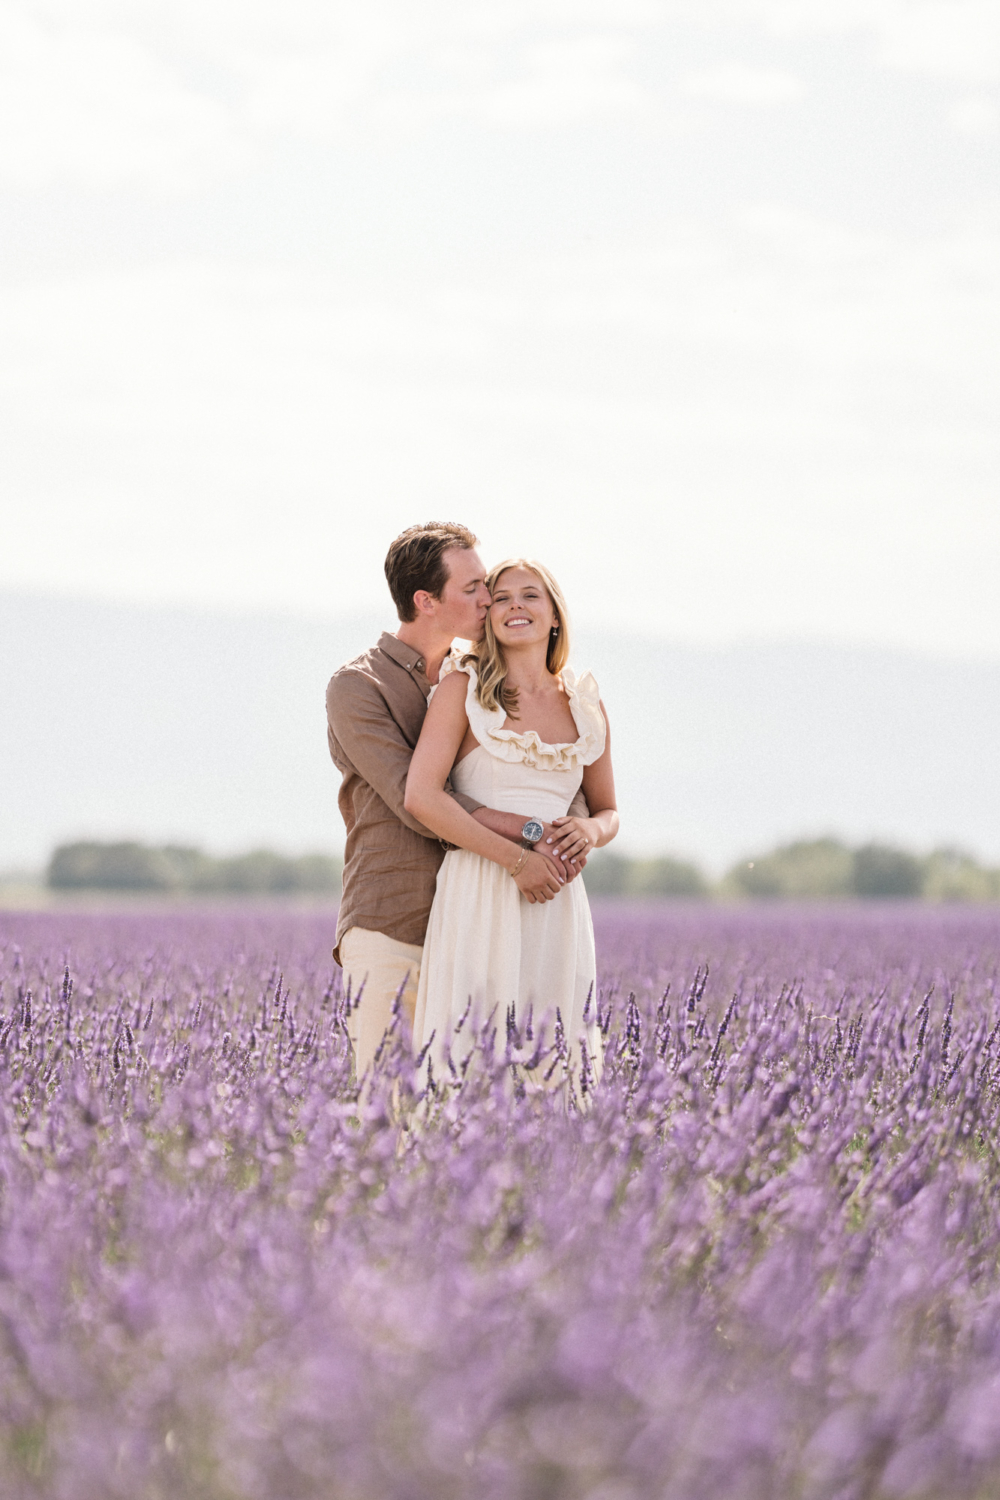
top-left (0, 0), bottom-right (1000, 656)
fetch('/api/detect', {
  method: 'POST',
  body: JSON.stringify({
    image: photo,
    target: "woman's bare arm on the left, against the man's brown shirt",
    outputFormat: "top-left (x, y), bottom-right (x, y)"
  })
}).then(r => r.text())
top-left (403, 672), bottom-right (565, 902)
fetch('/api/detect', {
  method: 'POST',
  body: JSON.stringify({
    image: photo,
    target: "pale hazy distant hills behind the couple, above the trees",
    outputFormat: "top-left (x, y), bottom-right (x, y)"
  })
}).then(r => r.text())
top-left (0, 585), bottom-right (1000, 872)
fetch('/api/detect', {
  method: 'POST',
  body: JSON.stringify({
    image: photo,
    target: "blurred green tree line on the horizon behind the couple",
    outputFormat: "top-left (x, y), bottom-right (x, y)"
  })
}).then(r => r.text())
top-left (46, 837), bottom-right (1000, 902)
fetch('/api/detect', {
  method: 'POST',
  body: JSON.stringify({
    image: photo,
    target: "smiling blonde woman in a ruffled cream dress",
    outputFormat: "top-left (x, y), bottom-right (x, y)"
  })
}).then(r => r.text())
top-left (406, 558), bottom-right (618, 1079)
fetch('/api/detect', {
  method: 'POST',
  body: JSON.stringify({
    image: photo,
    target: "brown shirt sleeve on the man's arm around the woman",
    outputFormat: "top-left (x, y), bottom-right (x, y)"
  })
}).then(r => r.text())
top-left (327, 672), bottom-right (483, 843)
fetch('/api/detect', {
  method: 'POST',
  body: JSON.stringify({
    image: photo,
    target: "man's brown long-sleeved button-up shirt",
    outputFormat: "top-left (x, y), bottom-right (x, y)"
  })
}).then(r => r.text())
top-left (327, 632), bottom-right (483, 959)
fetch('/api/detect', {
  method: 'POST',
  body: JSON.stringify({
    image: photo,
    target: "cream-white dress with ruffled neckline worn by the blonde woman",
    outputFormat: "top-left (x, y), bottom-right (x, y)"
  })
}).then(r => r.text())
top-left (414, 648), bottom-right (606, 1083)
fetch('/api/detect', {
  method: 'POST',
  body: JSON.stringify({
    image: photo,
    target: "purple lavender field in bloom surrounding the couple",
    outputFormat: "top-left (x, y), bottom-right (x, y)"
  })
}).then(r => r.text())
top-left (0, 905), bottom-right (1000, 1500)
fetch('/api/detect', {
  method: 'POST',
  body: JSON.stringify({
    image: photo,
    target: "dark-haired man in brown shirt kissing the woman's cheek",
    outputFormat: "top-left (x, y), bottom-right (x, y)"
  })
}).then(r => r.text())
top-left (327, 522), bottom-right (586, 1077)
